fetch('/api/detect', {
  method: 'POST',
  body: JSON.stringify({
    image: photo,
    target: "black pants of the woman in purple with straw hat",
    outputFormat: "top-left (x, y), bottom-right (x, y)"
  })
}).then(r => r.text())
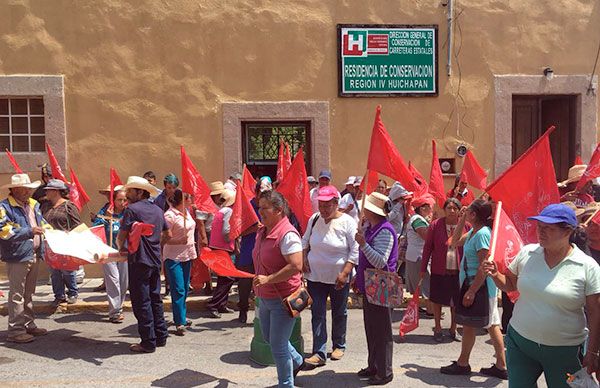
top-left (363, 295), bottom-right (394, 378)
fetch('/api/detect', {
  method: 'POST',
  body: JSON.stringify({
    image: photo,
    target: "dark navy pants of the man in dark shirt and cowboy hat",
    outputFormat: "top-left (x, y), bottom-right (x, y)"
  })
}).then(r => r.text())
top-left (128, 262), bottom-right (169, 349)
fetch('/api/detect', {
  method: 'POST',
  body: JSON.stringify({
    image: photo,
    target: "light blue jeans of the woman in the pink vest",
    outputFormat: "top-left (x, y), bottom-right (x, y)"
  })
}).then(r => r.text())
top-left (258, 298), bottom-right (304, 387)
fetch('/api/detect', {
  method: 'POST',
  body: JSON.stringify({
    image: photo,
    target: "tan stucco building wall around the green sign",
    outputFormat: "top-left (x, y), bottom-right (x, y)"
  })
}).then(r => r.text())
top-left (0, 0), bottom-right (600, 278)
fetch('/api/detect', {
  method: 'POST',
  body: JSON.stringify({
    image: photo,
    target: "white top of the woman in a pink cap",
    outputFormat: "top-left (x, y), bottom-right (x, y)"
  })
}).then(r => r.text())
top-left (302, 213), bottom-right (358, 284)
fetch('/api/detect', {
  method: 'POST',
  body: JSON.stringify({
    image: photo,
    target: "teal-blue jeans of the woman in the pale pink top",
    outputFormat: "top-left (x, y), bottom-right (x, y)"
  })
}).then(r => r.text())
top-left (165, 259), bottom-right (192, 326)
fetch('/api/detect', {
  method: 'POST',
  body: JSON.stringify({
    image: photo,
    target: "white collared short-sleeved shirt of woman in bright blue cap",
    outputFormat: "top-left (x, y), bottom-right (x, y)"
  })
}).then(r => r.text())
top-left (508, 244), bottom-right (600, 346)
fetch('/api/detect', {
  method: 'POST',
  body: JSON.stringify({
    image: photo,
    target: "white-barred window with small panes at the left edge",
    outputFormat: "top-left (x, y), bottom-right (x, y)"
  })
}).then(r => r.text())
top-left (0, 96), bottom-right (46, 153)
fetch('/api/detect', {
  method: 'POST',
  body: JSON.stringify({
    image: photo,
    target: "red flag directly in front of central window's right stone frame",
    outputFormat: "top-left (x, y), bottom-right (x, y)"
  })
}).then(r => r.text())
top-left (277, 148), bottom-right (312, 231)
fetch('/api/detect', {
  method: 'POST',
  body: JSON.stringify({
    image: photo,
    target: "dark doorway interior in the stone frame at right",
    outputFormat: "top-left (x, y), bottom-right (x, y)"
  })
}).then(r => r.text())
top-left (512, 95), bottom-right (577, 181)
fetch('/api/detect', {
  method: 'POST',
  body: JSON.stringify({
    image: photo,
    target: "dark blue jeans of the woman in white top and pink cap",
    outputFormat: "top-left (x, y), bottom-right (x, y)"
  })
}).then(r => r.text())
top-left (307, 280), bottom-right (350, 360)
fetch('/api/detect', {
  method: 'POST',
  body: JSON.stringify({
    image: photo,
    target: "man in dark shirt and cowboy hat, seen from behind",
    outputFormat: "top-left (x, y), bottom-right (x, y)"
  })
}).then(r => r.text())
top-left (117, 176), bottom-right (170, 353)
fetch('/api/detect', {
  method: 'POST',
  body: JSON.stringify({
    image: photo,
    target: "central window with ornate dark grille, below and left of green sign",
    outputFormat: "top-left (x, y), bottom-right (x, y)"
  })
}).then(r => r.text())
top-left (242, 121), bottom-right (311, 177)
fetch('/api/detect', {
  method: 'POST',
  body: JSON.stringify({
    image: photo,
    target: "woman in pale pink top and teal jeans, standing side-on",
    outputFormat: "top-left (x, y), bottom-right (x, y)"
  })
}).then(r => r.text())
top-left (163, 189), bottom-right (196, 336)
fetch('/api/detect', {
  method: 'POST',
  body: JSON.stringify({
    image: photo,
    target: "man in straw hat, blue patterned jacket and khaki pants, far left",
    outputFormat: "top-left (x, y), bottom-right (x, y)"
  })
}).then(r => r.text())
top-left (0, 174), bottom-right (51, 343)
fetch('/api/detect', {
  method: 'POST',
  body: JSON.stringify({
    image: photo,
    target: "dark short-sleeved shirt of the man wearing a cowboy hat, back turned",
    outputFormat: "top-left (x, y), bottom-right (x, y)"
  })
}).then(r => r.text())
top-left (121, 199), bottom-right (169, 268)
